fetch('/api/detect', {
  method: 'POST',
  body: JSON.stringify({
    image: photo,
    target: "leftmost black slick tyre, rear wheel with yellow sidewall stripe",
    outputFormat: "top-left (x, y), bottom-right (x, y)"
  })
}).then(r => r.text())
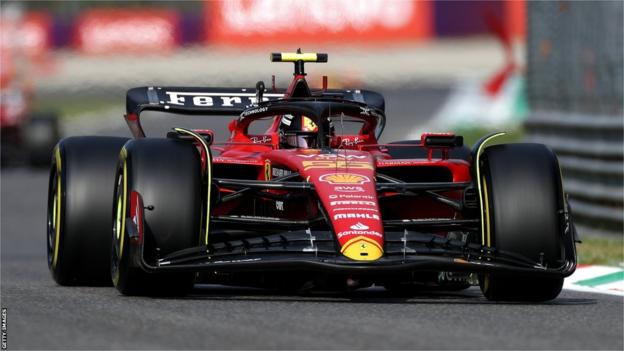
top-left (47, 136), bottom-right (127, 285)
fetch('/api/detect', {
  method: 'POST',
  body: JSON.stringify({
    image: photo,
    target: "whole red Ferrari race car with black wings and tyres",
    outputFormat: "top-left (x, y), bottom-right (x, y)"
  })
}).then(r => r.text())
top-left (47, 51), bottom-right (576, 301)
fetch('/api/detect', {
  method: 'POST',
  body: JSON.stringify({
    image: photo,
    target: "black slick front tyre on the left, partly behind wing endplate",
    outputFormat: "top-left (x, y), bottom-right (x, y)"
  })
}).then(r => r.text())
top-left (110, 139), bottom-right (202, 296)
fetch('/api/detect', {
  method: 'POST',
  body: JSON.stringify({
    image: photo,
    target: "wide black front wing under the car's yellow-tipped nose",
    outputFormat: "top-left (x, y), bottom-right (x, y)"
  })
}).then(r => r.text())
top-left (128, 221), bottom-right (576, 277)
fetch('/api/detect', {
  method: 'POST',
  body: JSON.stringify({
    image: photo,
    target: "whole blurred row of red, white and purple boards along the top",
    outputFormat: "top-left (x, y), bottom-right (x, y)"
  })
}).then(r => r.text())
top-left (0, 0), bottom-right (525, 55)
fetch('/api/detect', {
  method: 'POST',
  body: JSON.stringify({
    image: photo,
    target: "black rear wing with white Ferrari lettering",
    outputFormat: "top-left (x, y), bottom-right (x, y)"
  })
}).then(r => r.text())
top-left (126, 87), bottom-right (385, 138)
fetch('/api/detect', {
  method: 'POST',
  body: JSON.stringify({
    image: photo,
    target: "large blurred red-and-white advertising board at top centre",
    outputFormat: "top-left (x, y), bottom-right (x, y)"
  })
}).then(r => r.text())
top-left (205, 0), bottom-right (432, 47)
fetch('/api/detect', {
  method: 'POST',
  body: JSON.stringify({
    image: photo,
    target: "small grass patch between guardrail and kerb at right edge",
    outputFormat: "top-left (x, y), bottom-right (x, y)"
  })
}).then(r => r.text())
top-left (576, 236), bottom-right (624, 266)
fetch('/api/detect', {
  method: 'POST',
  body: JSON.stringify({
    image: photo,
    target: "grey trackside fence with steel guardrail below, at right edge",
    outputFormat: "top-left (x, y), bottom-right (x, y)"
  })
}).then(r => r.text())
top-left (526, 1), bottom-right (624, 235)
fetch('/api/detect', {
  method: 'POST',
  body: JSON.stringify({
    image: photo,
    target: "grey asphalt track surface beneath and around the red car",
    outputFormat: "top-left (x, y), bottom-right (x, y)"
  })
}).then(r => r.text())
top-left (0, 89), bottom-right (624, 350)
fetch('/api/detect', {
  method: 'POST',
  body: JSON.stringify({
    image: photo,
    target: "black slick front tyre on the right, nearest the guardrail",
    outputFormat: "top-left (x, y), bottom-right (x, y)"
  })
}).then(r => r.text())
top-left (479, 144), bottom-right (564, 302)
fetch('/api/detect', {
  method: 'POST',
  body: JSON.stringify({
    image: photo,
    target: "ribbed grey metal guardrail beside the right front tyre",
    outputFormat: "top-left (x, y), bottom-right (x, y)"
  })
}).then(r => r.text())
top-left (525, 112), bottom-right (624, 235)
